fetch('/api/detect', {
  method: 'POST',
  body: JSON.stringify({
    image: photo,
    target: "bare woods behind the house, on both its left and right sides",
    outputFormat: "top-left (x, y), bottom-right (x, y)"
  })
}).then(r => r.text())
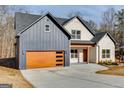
top-left (0, 5), bottom-right (124, 58)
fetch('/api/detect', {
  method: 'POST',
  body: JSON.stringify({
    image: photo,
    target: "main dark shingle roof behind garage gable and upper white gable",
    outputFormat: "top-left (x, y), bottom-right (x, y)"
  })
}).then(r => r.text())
top-left (14, 12), bottom-right (95, 35)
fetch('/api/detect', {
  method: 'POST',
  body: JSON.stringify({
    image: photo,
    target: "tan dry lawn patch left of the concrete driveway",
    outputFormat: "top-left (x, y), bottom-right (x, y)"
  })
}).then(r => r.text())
top-left (0, 66), bottom-right (33, 88)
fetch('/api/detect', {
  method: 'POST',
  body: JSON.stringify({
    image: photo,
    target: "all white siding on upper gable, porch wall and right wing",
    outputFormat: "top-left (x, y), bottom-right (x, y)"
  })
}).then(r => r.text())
top-left (64, 17), bottom-right (115, 63)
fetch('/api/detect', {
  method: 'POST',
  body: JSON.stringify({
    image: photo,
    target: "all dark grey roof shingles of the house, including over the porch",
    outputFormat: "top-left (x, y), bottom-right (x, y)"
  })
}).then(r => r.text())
top-left (14, 12), bottom-right (115, 44)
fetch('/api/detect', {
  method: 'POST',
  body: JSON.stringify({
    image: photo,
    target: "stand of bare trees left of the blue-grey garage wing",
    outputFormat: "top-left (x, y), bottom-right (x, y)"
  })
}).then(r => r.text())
top-left (0, 5), bottom-right (40, 58)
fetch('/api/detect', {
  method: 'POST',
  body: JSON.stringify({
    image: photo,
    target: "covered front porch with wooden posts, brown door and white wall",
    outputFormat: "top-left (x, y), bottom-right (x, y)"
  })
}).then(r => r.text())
top-left (70, 42), bottom-right (94, 63)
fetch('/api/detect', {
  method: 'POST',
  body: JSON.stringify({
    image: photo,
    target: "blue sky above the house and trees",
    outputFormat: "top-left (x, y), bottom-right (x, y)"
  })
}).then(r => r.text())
top-left (19, 5), bottom-right (124, 25)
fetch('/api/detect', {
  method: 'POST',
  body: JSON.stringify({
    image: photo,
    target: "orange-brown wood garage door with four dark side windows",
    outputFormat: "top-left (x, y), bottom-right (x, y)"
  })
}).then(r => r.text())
top-left (26, 51), bottom-right (64, 69)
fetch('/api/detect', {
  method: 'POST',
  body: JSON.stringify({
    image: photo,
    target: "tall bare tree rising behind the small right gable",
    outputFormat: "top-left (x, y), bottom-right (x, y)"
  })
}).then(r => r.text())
top-left (99, 8), bottom-right (117, 38)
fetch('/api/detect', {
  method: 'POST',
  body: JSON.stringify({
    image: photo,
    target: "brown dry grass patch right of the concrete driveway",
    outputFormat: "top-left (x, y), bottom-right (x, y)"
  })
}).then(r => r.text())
top-left (96, 66), bottom-right (124, 76)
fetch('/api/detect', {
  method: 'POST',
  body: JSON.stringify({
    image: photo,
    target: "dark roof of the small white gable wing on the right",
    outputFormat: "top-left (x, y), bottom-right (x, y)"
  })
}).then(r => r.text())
top-left (91, 32), bottom-right (117, 44)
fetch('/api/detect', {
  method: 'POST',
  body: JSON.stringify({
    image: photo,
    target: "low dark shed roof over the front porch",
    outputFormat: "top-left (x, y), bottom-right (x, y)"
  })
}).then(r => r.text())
top-left (71, 40), bottom-right (95, 45)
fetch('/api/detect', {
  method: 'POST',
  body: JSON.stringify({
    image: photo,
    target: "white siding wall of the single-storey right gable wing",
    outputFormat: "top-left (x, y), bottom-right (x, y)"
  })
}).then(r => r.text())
top-left (89, 34), bottom-right (115, 63)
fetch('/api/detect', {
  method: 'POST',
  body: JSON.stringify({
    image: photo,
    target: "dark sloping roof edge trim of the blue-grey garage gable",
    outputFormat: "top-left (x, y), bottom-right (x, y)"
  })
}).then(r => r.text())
top-left (17, 13), bottom-right (71, 39)
